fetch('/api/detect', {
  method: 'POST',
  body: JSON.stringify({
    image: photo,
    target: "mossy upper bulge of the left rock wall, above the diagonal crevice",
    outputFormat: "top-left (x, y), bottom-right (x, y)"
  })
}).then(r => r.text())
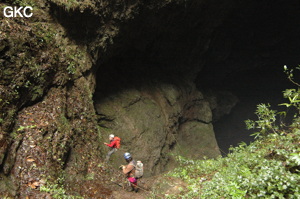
top-left (0, 0), bottom-right (92, 137)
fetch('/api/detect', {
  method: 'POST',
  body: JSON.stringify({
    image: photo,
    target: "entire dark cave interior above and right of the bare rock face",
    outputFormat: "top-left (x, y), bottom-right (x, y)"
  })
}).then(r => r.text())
top-left (96, 0), bottom-right (300, 154)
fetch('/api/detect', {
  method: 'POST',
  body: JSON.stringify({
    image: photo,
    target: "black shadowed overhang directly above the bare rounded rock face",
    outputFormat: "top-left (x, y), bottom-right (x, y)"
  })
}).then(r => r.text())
top-left (96, 1), bottom-right (232, 98)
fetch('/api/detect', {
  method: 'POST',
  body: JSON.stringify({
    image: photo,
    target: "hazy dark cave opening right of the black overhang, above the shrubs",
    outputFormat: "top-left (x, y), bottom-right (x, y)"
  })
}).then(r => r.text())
top-left (197, 0), bottom-right (300, 154)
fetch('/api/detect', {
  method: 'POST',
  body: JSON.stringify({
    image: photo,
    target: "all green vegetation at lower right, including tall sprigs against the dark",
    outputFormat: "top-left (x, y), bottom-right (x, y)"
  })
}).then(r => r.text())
top-left (166, 67), bottom-right (300, 198)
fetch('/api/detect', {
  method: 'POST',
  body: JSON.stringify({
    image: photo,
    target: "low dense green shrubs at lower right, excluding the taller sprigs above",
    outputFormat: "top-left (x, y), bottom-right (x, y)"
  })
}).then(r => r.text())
top-left (168, 130), bottom-right (300, 198)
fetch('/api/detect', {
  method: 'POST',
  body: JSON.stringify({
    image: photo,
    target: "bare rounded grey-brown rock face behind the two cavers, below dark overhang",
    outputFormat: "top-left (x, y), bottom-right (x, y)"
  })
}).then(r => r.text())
top-left (95, 81), bottom-right (220, 175)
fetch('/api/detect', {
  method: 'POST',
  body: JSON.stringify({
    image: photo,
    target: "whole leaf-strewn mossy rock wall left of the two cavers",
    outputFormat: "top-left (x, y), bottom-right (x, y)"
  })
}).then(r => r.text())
top-left (0, 0), bottom-right (156, 198)
